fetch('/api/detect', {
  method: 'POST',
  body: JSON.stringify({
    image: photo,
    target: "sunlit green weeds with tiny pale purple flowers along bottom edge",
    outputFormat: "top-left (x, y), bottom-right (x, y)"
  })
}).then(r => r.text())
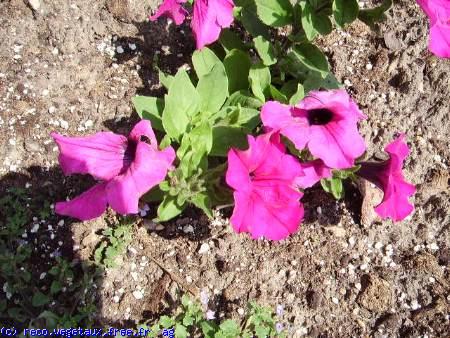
top-left (138, 295), bottom-right (287, 338)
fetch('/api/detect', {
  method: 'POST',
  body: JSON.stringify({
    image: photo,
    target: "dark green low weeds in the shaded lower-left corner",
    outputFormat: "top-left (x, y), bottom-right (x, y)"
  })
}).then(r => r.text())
top-left (0, 189), bottom-right (99, 329)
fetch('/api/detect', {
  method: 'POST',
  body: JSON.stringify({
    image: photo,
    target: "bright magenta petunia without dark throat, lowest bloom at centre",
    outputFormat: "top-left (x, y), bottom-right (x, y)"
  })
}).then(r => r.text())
top-left (226, 134), bottom-right (303, 240)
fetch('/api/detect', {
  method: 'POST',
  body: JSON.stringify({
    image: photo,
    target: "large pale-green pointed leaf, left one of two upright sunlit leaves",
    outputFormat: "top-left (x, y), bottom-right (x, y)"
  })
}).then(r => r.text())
top-left (162, 69), bottom-right (200, 140)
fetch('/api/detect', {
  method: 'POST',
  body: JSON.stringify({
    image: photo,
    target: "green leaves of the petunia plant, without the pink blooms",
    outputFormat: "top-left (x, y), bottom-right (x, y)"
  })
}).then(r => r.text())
top-left (135, 0), bottom-right (390, 222)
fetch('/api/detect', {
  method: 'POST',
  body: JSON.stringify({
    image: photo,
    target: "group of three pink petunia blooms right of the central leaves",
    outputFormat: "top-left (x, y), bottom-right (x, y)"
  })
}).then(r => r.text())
top-left (227, 90), bottom-right (415, 240)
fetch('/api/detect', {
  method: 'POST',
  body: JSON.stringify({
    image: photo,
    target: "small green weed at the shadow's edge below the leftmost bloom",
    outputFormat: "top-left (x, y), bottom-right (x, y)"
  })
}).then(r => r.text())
top-left (94, 218), bottom-right (133, 268)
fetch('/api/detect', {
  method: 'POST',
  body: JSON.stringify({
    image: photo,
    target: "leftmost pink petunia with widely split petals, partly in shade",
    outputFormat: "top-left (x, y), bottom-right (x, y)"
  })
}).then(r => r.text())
top-left (51, 120), bottom-right (175, 220)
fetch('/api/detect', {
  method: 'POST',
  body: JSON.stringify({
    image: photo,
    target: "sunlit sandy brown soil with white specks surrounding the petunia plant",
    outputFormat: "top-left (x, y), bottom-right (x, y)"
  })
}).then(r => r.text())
top-left (0, 0), bottom-right (450, 337)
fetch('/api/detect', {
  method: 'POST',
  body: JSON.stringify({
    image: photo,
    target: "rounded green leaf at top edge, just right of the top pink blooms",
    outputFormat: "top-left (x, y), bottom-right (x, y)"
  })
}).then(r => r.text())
top-left (255, 0), bottom-right (293, 27)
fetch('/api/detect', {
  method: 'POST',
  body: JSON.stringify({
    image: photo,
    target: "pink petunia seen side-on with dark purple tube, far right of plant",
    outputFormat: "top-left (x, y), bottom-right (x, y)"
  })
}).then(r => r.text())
top-left (357, 134), bottom-right (416, 221)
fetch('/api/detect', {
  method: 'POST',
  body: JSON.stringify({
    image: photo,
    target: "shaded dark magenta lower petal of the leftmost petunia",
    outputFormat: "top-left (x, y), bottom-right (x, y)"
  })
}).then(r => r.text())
top-left (55, 183), bottom-right (107, 221)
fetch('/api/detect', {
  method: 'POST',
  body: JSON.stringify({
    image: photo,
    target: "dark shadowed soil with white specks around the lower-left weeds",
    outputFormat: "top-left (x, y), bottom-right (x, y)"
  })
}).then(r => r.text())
top-left (0, 166), bottom-right (102, 329)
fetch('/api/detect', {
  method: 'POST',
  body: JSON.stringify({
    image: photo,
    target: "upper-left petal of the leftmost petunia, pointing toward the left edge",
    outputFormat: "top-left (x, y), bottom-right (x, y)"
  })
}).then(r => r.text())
top-left (51, 132), bottom-right (128, 180)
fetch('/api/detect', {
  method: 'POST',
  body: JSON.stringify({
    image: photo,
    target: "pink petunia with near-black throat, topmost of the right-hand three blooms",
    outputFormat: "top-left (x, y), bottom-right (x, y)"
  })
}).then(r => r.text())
top-left (261, 89), bottom-right (366, 169)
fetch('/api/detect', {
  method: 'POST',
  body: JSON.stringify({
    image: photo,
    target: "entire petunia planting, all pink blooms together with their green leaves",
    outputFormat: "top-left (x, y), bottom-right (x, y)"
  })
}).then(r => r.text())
top-left (52, 0), bottom-right (430, 240)
